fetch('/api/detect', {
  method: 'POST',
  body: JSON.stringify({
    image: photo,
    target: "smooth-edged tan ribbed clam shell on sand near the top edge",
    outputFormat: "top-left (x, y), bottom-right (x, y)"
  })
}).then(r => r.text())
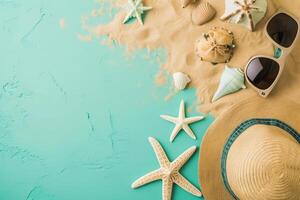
top-left (192, 2), bottom-right (216, 25)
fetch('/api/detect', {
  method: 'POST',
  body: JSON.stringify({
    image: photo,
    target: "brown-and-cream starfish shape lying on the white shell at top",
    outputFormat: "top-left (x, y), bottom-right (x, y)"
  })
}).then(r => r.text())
top-left (221, 0), bottom-right (259, 31)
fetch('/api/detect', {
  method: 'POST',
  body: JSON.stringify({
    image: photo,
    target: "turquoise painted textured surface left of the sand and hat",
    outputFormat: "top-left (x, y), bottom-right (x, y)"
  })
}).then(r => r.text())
top-left (0, 0), bottom-right (213, 200)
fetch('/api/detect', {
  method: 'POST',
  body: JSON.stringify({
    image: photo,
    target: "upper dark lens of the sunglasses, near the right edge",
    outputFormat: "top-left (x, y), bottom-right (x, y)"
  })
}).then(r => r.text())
top-left (267, 13), bottom-right (298, 48)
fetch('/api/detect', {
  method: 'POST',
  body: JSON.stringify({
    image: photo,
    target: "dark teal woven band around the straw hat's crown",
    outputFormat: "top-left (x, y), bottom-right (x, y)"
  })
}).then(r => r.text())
top-left (221, 119), bottom-right (300, 200)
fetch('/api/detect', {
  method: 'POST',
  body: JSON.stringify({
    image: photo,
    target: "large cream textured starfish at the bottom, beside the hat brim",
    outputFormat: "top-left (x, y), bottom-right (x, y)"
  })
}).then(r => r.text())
top-left (132, 137), bottom-right (202, 200)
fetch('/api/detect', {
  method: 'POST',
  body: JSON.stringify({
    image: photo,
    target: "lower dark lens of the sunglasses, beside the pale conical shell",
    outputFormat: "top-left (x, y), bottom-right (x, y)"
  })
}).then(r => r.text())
top-left (246, 58), bottom-right (279, 90)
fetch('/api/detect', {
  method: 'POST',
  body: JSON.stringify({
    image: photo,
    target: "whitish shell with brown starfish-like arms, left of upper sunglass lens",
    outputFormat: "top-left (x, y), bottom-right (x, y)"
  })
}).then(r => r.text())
top-left (220, 0), bottom-right (268, 31)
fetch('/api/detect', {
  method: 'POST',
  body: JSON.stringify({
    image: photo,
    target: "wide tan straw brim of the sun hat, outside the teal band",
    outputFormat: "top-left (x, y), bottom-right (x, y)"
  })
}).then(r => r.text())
top-left (199, 97), bottom-right (300, 200)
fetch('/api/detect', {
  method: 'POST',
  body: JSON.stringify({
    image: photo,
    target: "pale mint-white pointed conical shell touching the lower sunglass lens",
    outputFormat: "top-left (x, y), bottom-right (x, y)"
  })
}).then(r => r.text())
top-left (212, 65), bottom-right (246, 102)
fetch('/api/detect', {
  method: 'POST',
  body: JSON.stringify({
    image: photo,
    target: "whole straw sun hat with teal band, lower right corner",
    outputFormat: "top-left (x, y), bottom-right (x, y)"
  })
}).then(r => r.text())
top-left (199, 98), bottom-right (300, 200)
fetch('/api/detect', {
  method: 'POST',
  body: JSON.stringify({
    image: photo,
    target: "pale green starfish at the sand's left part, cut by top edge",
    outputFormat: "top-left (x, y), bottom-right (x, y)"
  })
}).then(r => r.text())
top-left (123, 0), bottom-right (152, 25)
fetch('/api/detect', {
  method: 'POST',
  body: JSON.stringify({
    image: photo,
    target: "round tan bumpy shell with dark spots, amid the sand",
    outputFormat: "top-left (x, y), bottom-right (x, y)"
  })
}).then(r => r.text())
top-left (195, 27), bottom-right (235, 64)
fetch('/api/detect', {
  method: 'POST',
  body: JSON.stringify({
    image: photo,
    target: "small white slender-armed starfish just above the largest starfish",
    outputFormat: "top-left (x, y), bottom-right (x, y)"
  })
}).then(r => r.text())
top-left (160, 100), bottom-right (204, 142)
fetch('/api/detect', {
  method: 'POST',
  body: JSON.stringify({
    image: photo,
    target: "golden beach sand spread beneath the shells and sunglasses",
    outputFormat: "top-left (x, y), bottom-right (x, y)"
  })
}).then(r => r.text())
top-left (85, 0), bottom-right (300, 117)
